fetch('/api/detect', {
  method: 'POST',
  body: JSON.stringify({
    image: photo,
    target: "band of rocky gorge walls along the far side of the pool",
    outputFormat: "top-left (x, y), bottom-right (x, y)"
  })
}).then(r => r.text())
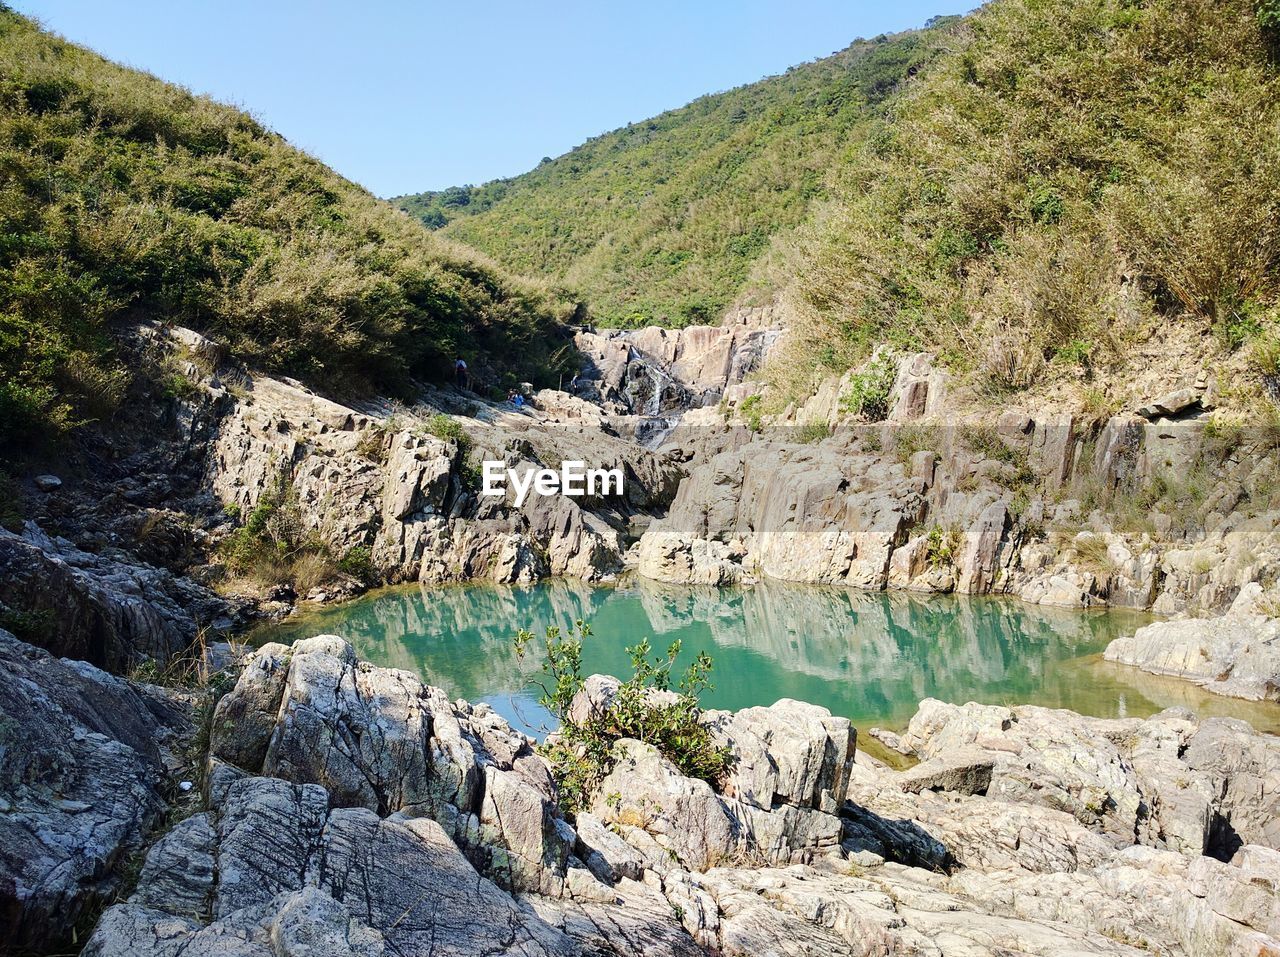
top-left (10, 308), bottom-right (1280, 700)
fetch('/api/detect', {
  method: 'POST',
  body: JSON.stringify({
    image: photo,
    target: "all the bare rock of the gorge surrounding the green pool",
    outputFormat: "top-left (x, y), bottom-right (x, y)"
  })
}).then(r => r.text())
top-left (0, 313), bottom-right (1280, 954)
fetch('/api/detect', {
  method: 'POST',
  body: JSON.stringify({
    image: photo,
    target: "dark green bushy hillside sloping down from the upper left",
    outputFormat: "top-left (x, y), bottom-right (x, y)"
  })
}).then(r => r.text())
top-left (0, 5), bottom-right (562, 444)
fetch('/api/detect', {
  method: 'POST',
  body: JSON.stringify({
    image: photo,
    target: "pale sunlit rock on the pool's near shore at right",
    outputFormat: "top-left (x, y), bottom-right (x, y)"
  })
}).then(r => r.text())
top-left (880, 699), bottom-right (1280, 866)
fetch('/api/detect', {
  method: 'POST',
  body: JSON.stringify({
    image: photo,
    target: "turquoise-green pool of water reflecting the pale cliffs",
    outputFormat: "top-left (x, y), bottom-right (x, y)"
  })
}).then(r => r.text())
top-left (257, 578), bottom-right (1280, 731)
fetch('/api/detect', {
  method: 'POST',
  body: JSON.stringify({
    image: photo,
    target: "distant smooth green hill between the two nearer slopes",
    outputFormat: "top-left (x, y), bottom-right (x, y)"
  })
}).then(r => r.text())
top-left (393, 18), bottom-right (955, 326)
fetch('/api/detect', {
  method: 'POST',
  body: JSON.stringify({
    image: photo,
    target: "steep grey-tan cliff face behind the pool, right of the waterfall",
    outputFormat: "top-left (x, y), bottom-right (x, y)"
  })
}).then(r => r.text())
top-left (634, 354), bottom-right (1280, 624)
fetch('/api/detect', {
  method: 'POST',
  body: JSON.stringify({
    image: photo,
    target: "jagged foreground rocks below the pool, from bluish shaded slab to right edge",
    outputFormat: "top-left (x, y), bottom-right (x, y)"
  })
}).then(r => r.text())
top-left (52, 637), bottom-right (1280, 957)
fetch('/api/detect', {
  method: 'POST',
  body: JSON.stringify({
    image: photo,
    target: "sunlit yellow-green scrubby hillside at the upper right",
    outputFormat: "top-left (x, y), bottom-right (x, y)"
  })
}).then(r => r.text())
top-left (774, 0), bottom-right (1280, 415)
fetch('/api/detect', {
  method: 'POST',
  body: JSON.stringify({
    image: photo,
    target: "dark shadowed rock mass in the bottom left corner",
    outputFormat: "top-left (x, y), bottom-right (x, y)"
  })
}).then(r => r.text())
top-left (0, 631), bottom-right (189, 951)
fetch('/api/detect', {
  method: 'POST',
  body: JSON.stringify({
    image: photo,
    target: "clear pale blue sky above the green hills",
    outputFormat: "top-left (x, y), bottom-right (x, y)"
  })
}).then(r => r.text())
top-left (9, 0), bottom-right (977, 196)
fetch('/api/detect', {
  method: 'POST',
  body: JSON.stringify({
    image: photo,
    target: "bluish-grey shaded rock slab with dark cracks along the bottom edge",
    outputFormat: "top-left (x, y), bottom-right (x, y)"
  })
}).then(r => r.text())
top-left (84, 778), bottom-right (579, 957)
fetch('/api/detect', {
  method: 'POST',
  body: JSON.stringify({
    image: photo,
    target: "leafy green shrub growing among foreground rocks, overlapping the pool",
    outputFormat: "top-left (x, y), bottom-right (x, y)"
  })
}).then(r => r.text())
top-left (515, 621), bottom-right (731, 812)
